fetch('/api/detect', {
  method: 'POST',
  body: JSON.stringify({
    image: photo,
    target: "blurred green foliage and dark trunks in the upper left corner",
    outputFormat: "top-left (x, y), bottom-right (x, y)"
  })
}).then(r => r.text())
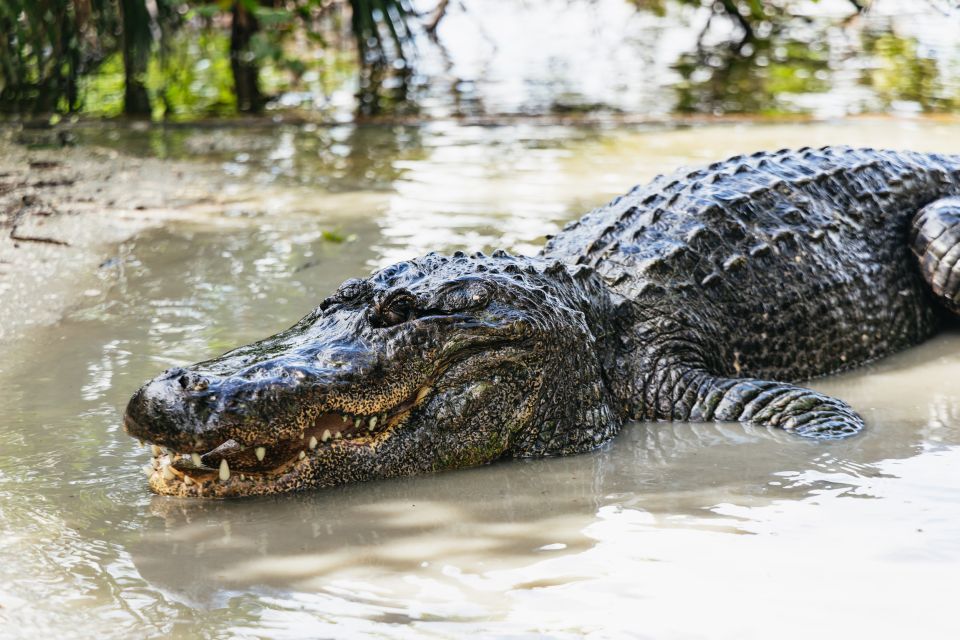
top-left (0, 0), bottom-right (415, 118)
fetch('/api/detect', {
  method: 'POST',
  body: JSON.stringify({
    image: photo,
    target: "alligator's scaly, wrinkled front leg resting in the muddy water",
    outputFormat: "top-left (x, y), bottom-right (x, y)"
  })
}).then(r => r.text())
top-left (647, 370), bottom-right (863, 439)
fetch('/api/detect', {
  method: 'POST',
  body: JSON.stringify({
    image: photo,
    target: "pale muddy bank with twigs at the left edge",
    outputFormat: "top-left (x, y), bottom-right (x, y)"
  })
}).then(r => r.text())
top-left (0, 131), bottom-right (251, 344)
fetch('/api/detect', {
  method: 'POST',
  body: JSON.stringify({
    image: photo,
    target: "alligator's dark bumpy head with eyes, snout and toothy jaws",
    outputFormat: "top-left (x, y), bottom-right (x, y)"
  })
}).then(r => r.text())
top-left (124, 252), bottom-right (620, 497)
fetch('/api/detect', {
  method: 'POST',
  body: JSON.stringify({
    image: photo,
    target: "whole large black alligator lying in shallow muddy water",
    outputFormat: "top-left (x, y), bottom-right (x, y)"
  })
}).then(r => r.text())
top-left (124, 147), bottom-right (960, 497)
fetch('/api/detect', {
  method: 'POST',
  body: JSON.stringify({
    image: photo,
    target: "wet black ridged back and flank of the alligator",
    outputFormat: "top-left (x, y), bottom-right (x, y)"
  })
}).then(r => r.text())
top-left (543, 147), bottom-right (960, 380)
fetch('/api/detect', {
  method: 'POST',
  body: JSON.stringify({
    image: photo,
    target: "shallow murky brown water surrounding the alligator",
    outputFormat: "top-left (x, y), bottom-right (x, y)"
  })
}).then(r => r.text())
top-left (0, 120), bottom-right (960, 639)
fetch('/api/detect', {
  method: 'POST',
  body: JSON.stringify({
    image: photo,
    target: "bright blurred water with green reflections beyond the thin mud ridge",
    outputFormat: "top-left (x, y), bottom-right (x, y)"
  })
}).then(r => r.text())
top-left (419, 0), bottom-right (960, 118)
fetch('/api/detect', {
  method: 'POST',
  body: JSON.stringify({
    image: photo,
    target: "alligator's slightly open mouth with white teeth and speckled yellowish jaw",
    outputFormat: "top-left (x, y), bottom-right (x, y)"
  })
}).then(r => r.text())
top-left (124, 387), bottom-right (430, 496)
